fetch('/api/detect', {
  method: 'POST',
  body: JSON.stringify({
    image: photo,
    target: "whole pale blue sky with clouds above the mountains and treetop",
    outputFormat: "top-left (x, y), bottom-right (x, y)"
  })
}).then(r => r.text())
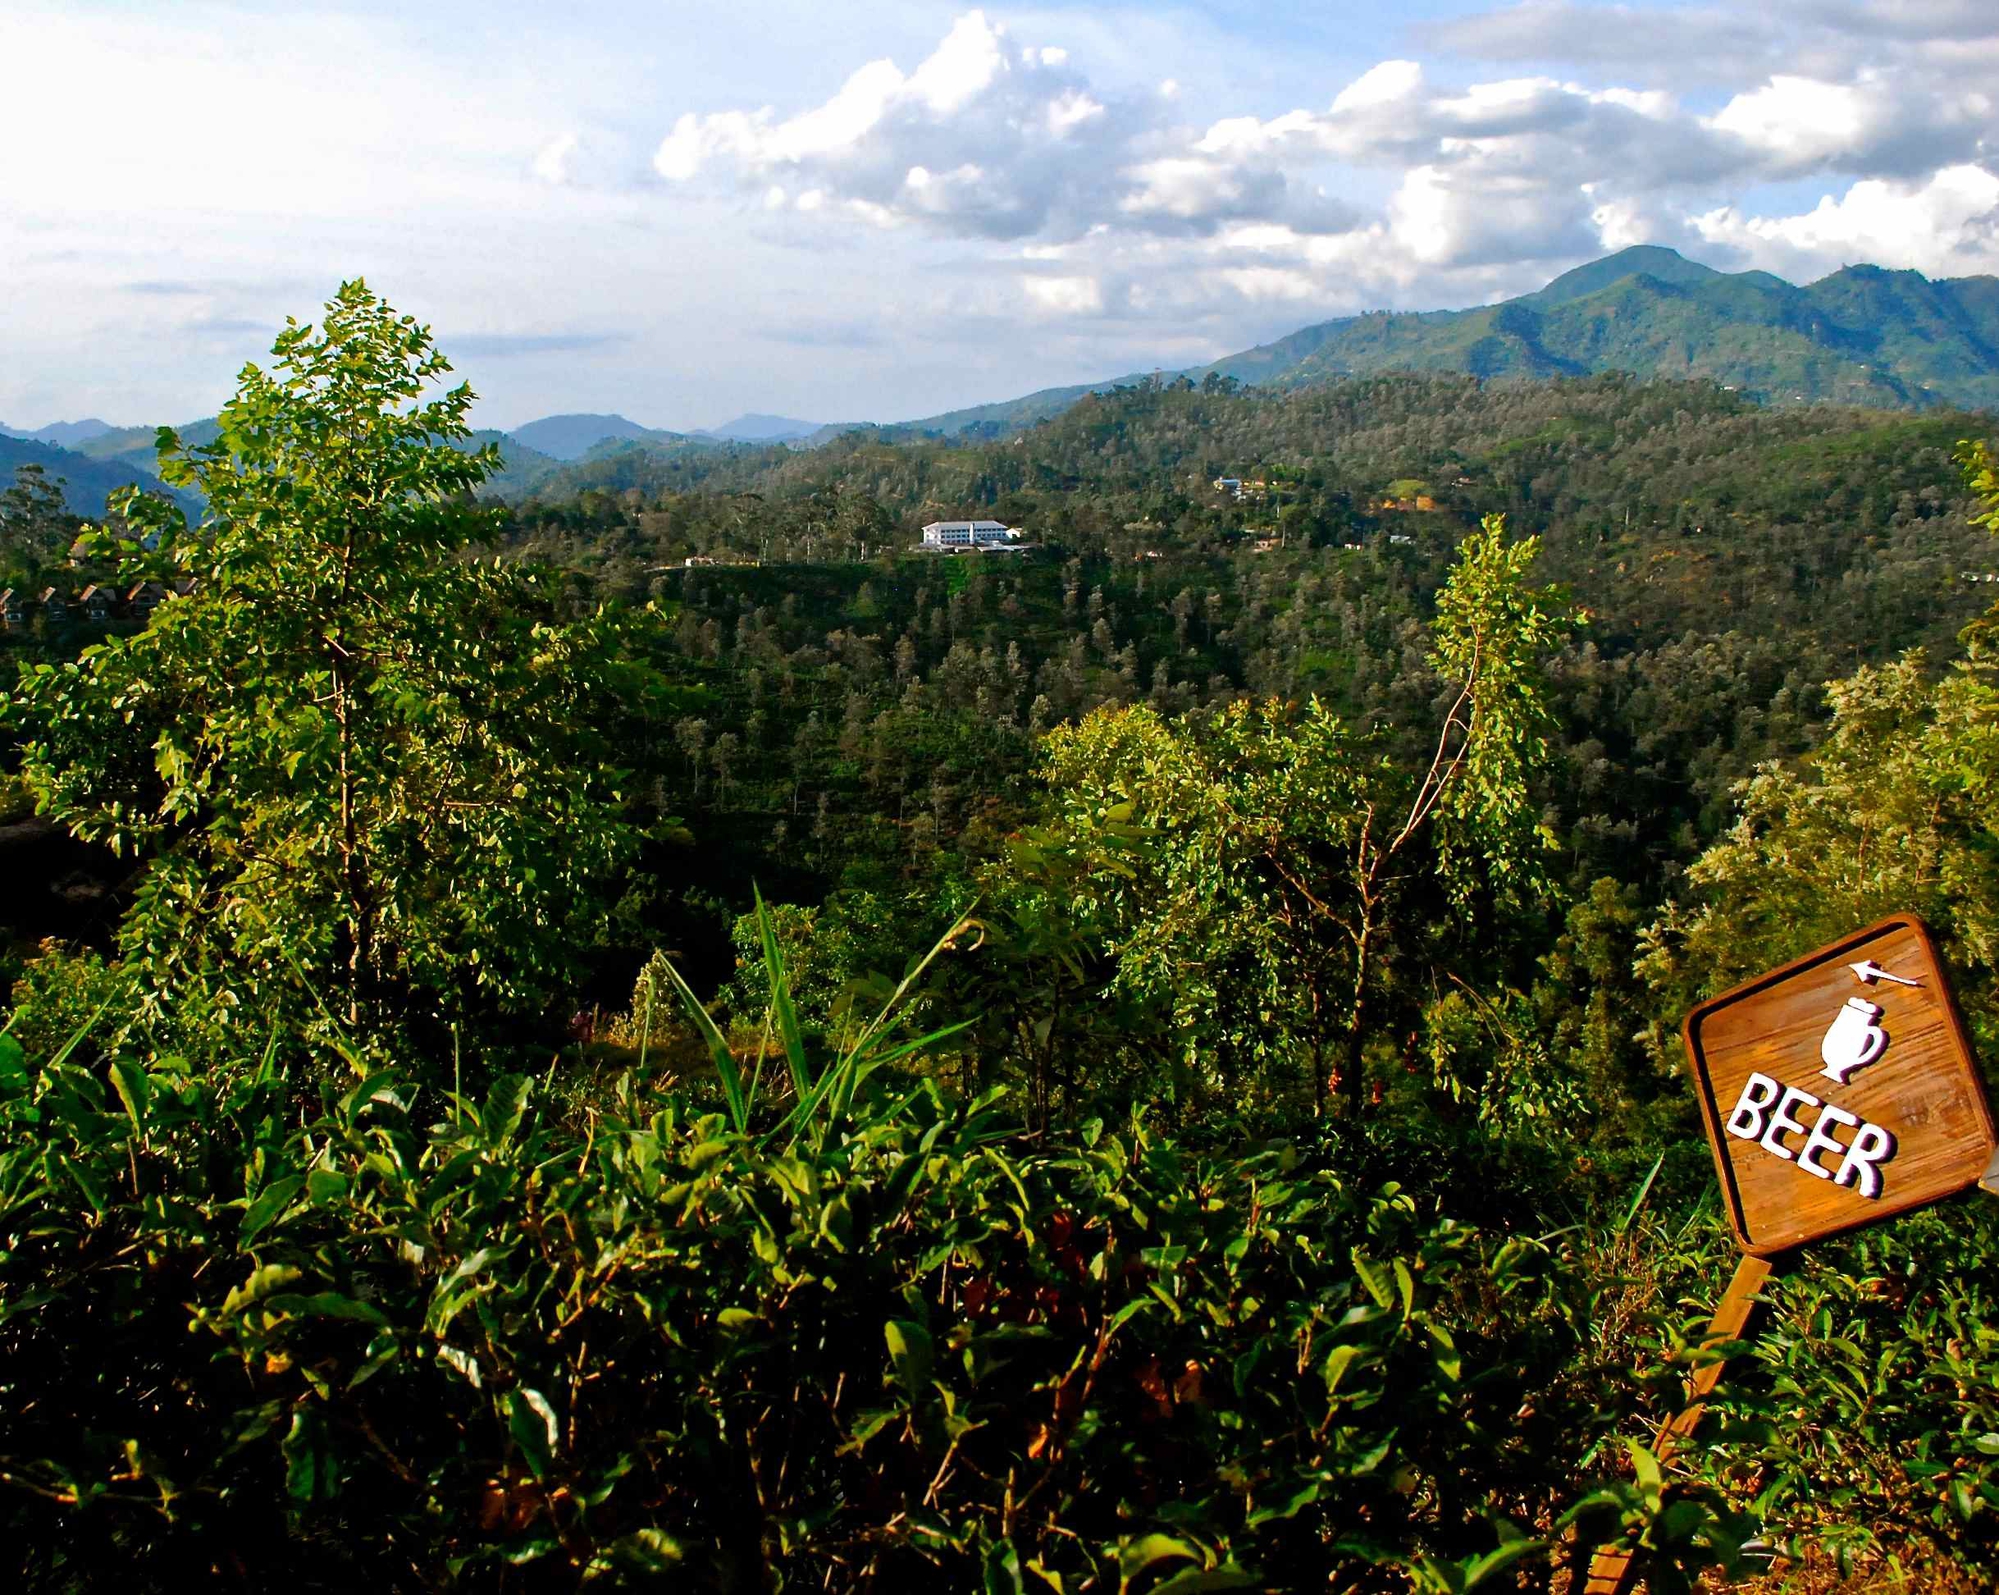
top-left (0, 0), bottom-right (1999, 430)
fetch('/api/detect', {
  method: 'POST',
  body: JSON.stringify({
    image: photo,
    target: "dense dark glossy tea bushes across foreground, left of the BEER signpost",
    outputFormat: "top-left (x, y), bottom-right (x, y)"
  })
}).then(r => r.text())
top-left (0, 1019), bottom-right (1751, 1591)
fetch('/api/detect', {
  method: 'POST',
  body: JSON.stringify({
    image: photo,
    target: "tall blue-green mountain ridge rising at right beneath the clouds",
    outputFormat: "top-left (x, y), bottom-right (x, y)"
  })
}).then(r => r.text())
top-left (888, 244), bottom-right (1999, 436)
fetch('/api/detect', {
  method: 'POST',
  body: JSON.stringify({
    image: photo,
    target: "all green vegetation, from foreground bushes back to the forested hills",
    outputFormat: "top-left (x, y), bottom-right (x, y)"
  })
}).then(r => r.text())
top-left (11, 284), bottom-right (1999, 1595)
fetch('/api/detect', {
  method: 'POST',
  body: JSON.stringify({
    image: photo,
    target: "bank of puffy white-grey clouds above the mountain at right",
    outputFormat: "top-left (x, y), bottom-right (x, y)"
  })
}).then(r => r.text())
top-left (639, 0), bottom-right (1995, 341)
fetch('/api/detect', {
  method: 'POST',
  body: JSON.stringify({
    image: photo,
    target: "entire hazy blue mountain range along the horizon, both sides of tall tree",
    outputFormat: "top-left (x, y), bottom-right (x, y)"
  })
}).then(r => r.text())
top-left (0, 244), bottom-right (1999, 514)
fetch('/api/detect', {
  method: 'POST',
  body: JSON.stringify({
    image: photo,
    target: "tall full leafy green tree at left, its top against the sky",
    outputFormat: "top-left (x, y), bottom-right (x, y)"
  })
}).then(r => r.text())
top-left (8, 282), bottom-right (636, 1071)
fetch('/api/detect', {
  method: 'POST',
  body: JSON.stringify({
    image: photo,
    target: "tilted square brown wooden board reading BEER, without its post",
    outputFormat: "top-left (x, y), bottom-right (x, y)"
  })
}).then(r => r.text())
top-left (1685, 913), bottom-right (1995, 1257)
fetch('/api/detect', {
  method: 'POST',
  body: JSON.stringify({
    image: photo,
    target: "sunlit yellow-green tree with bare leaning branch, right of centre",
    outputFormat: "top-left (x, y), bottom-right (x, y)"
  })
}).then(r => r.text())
top-left (1045, 516), bottom-right (1565, 1111)
